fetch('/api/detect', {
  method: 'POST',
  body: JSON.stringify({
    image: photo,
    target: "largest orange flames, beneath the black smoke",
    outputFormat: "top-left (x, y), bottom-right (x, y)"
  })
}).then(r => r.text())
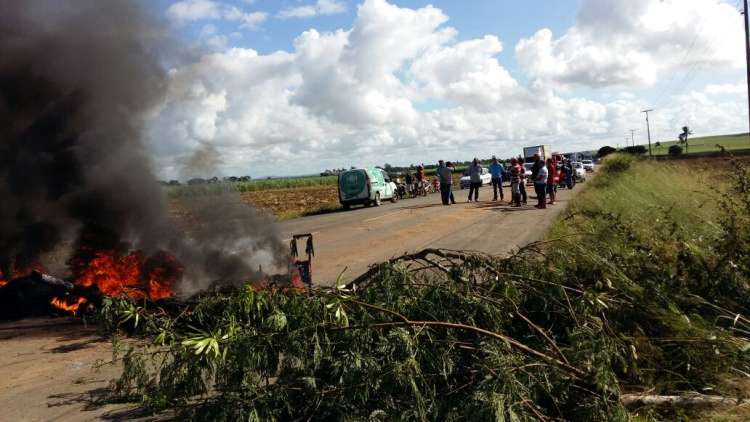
top-left (75, 251), bottom-right (182, 300)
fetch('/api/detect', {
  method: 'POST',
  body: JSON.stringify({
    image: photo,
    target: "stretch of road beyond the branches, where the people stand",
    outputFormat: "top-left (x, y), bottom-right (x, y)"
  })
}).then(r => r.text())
top-left (280, 181), bottom-right (582, 286)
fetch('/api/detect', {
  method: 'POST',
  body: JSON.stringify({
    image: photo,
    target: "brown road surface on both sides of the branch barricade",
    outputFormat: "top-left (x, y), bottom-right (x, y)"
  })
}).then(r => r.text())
top-left (0, 179), bottom-right (580, 421)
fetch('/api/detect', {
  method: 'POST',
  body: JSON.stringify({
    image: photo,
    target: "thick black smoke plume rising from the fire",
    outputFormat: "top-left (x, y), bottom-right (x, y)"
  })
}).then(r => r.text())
top-left (0, 0), bottom-right (285, 296)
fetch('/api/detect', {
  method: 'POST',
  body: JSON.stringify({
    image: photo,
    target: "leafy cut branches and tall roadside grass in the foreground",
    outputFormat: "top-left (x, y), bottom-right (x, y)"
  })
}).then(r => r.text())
top-left (100, 154), bottom-right (750, 421)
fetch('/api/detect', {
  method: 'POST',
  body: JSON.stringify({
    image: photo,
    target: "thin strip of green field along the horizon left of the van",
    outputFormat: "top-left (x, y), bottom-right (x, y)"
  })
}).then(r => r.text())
top-left (165, 176), bottom-right (338, 197)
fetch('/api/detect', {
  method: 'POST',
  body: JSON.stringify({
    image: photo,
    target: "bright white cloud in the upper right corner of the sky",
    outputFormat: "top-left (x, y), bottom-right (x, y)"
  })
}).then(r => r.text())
top-left (516, 0), bottom-right (744, 88)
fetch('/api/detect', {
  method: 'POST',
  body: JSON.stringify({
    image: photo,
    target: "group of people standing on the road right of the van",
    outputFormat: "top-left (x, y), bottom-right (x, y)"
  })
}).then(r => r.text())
top-left (437, 155), bottom-right (559, 209)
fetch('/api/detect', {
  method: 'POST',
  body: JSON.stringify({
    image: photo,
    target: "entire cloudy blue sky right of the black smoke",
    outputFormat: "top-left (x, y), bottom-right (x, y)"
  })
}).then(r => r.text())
top-left (147, 0), bottom-right (748, 179)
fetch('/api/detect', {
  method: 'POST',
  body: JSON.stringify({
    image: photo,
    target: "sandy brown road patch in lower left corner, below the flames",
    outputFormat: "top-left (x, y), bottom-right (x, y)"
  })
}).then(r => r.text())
top-left (0, 318), bottom-right (148, 421)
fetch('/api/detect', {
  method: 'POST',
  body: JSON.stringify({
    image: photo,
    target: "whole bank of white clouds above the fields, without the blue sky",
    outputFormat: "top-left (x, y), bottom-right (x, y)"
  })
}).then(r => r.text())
top-left (150, 0), bottom-right (747, 177)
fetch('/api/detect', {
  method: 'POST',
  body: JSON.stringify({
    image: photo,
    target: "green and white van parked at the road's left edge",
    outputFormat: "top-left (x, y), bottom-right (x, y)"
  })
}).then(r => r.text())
top-left (339, 167), bottom-right (398, 210)
